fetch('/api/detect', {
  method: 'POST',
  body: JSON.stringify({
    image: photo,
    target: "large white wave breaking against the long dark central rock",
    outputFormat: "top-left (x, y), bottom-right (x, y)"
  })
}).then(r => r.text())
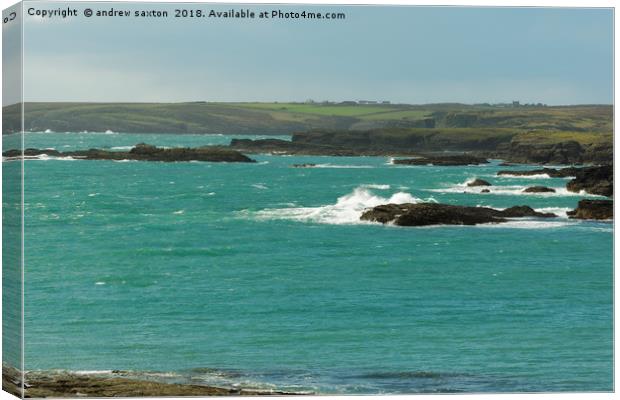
top-left (255, 186), bottom-right (435, 225)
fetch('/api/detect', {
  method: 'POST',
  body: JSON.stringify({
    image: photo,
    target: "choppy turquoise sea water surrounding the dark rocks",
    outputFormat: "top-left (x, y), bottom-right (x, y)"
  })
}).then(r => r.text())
top-left (12, 133), bottom-right (613, 393)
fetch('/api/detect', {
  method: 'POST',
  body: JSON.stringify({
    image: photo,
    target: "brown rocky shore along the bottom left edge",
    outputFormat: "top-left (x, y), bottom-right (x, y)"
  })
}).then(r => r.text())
top-left (2, 366), bottom-right (301, 398)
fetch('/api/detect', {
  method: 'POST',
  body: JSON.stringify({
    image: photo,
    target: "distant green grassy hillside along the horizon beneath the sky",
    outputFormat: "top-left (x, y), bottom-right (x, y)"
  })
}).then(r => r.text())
top-left (3, 102), bottom-right (613, 134)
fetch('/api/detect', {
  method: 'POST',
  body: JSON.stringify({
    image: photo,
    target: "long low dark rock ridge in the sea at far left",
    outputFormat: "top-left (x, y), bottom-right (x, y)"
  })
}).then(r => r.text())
top-left (2, 143), bottom-right (256, 162)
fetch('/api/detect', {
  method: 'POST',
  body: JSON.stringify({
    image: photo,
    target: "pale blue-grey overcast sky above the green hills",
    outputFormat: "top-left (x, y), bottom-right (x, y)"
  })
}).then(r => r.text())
top-left (3, 2), bottom-right (613, 105)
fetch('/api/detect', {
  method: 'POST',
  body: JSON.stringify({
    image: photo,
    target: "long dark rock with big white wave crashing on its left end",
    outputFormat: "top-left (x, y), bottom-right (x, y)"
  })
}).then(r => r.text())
top-left (360, 203), bottom-right (556, 226)
